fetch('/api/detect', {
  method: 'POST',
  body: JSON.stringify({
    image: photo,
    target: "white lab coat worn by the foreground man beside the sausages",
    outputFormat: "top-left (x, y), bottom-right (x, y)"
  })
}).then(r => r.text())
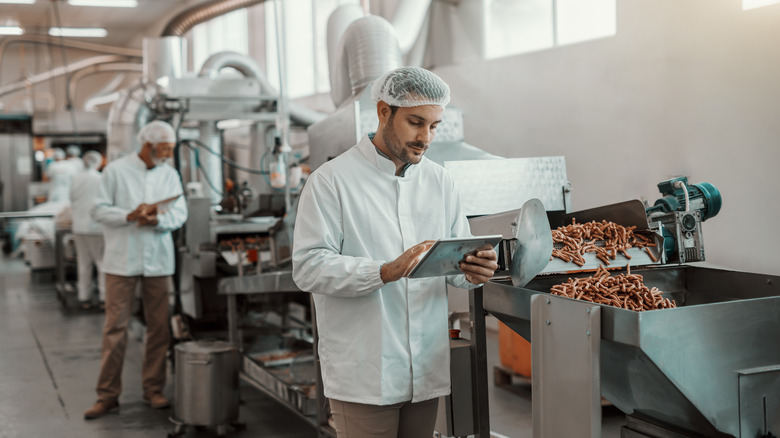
top-left (293, 137), bottom-right (475, 405)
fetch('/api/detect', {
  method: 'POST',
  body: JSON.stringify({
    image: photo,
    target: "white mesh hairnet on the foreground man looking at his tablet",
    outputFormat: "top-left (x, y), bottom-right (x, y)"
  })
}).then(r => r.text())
top-left (371, 67), bottom-right (450, 107)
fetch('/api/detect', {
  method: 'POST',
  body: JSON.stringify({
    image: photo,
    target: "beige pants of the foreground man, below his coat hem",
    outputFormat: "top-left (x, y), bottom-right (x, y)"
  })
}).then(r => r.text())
top-left (329, 398), bottom-right (439, 438)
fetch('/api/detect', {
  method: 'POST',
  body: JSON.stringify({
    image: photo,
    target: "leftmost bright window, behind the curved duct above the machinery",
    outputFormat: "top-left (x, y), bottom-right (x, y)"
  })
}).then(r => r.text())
top-left (192, 9), bottom-right (249, 71)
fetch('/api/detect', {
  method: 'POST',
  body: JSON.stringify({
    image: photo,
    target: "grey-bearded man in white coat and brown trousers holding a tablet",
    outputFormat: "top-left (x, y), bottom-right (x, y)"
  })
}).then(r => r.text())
top-left (84, 121), bottom-right (187, 419)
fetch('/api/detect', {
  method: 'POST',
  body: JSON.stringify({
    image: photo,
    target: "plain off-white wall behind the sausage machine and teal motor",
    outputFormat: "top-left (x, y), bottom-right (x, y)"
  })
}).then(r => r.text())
top-left (433, 0), bottom-right (780, 274)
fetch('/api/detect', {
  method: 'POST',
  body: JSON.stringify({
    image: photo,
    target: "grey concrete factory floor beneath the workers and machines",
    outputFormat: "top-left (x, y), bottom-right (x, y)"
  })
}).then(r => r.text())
top-left (0, 258), bottom-right (625, 438)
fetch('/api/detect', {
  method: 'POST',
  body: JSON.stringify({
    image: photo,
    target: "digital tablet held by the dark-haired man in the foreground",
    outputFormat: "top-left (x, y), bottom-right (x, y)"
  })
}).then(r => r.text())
top-left (409, 234), bottom-right (503, 278)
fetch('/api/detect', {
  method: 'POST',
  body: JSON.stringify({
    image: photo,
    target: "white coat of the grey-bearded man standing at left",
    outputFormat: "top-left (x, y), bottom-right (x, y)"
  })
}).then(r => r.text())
top-left (91, 154), bottom-right (187, 277)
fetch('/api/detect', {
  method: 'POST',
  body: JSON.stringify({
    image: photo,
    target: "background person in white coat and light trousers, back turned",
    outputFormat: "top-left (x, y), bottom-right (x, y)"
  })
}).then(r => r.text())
top-left (70, 151), bottom-right (106, 309)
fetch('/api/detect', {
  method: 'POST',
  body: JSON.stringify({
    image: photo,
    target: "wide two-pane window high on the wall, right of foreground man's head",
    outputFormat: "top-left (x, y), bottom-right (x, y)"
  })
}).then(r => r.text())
top-left (484, 0), bottom-right (616, 59)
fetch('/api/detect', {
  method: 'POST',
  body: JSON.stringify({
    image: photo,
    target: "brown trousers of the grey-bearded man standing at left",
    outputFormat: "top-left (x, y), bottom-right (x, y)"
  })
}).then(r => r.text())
top-left (97, 274), bottom-right (170, 400)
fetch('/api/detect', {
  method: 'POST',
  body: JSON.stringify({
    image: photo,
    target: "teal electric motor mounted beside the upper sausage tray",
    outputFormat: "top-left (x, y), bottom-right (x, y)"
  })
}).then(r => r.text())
top-left (647, 176), bottom-right (723, 222)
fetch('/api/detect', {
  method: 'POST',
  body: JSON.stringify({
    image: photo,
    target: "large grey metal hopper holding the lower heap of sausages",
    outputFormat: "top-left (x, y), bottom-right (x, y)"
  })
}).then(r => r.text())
top-left (483, 265), bottom-right (780, 437)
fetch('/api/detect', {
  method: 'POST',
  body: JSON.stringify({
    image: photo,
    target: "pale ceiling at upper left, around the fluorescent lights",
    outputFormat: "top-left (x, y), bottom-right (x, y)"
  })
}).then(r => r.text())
top-left (0, 0), bottom-right (195, 48)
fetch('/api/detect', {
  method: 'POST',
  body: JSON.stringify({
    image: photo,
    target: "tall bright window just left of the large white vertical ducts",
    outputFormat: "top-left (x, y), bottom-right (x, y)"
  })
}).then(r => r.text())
top-left (264, 0), bottom-right (359, 98)
